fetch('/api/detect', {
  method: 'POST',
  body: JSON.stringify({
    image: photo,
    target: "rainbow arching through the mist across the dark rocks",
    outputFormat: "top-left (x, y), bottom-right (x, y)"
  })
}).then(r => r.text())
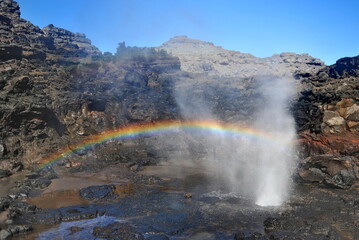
top-left (38, 120), bottom-right (290, 168)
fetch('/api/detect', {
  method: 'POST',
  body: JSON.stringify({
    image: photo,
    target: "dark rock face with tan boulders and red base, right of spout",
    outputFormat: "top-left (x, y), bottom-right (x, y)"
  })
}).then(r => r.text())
top-left (293, 54), bottom-right (359, 165)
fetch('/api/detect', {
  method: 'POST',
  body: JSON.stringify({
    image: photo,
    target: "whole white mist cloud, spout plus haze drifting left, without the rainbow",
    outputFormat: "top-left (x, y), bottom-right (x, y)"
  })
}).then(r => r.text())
top-left (167, 77), bottom-right (295, 206)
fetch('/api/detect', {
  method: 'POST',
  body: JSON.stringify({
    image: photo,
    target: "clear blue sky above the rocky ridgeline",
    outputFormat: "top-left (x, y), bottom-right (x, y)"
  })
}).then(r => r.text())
top-left (18, 0), bottom-right (359, 64)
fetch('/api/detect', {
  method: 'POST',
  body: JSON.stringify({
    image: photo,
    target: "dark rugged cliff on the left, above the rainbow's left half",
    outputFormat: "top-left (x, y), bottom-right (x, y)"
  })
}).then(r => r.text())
top-left (0, 0), bottom-right (180, 170)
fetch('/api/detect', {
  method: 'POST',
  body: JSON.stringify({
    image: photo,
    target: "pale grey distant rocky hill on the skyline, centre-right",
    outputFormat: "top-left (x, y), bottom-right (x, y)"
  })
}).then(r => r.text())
top-left (159, 36), bottom-right (325, 78)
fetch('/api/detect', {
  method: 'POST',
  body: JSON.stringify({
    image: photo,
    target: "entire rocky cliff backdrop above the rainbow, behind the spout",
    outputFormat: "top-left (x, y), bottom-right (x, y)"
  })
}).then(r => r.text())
top-left (0, 0), bottom-right (359, 189)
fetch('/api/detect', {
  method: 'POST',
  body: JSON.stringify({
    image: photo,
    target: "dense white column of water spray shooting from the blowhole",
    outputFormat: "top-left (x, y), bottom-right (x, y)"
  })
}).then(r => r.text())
top-left (254, 78), bottom-right (296, 206)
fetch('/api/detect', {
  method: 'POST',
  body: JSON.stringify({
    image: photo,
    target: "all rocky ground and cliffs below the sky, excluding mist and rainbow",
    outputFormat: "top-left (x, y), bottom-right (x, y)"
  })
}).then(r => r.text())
top-left (0, 0), bottom-right (359, 239)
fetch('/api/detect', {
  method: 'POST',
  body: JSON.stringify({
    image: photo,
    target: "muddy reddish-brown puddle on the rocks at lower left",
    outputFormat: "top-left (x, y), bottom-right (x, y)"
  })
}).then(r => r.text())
top-left (26, 190), bottom-right (88, 209)
